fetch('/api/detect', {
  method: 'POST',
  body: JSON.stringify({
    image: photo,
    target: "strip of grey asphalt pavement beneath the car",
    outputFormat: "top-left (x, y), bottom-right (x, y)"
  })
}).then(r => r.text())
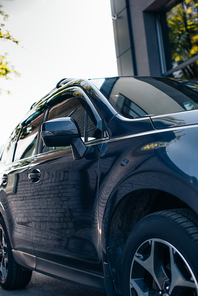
top-left (0, 272), bottom-right (105, 296)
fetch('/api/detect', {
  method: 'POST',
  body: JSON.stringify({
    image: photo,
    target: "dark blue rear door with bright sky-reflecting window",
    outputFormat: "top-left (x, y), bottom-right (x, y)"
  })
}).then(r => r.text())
top-left (0, 110), bottom-right (43, 267)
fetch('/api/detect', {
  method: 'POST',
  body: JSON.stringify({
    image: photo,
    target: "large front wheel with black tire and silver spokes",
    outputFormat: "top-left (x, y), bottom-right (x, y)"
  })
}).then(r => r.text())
top-left (121, 209), bottom-right (198, 296)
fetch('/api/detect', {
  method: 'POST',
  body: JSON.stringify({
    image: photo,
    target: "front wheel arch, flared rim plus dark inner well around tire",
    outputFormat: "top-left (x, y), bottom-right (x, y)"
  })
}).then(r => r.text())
top-left (102, 172), bottom-right (198, 293)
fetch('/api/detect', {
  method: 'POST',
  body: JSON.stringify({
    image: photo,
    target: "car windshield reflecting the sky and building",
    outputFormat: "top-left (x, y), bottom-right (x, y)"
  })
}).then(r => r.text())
top-left (91, 77), bottom-right (198, 118)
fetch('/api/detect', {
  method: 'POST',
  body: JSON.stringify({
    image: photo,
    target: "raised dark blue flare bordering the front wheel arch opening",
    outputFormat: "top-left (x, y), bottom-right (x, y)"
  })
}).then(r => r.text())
top-left (100, 171), bottom-right (198, 250)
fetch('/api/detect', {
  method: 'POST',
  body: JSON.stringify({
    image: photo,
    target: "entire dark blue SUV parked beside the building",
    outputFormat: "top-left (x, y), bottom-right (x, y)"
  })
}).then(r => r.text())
top-left (0, 77), bottom-right (198, 296)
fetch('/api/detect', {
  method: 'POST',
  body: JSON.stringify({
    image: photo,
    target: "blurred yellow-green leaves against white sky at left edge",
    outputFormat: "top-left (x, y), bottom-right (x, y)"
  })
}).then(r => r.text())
top-left (0, 4), bottom-right (19, 94)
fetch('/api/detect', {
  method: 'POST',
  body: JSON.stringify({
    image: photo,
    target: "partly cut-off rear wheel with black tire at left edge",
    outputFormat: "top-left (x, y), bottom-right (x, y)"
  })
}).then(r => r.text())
top-left (0, 217), bottom-right (32, 290)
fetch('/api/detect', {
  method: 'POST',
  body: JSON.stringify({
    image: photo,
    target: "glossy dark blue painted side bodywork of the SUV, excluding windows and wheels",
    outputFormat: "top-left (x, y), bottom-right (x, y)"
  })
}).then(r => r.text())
top-left (0, 78), bottom-right (198, 292)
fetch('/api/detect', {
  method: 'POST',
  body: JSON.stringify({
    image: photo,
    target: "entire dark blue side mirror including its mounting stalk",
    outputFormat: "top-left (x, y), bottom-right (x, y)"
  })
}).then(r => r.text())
top-left (41, 117), bottom-right (87, 159)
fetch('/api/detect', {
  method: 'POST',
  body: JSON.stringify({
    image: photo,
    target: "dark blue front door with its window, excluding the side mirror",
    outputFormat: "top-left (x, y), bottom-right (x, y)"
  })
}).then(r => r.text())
top-left (29, 88), bottom-right (104, 270)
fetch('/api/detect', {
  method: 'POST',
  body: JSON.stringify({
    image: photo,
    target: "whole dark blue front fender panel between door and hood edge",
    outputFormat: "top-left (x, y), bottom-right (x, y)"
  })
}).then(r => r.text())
top-left (98, 125), bottom-right (198, 252)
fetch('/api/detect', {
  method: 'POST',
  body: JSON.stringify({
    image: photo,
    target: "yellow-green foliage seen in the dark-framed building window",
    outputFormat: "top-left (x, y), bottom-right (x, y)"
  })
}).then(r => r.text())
top-left (166, 0), bottom-right (198, 78)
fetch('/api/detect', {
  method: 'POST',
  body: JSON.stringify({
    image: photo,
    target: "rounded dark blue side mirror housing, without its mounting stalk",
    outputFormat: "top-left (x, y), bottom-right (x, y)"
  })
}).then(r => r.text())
top-left (41, 117), bottom-right (80, 147)
